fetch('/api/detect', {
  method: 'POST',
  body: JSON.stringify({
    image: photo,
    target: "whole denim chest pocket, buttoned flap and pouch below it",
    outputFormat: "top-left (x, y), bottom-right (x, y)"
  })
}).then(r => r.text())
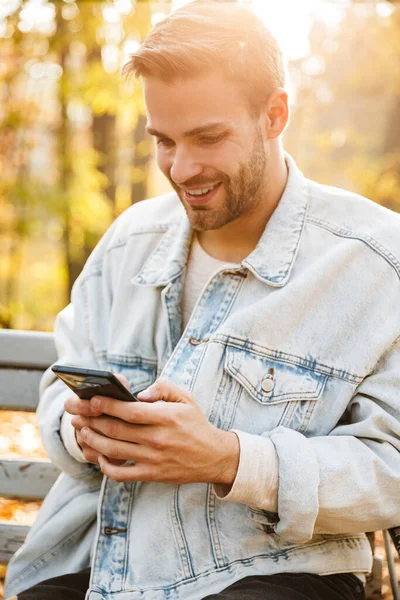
top-left (224, 347), bottom-right (327, 434)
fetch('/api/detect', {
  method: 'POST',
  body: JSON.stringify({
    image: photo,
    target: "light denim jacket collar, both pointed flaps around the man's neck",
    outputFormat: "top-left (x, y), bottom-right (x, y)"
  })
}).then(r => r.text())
top-left (131, 154), bottom-right (308, 287)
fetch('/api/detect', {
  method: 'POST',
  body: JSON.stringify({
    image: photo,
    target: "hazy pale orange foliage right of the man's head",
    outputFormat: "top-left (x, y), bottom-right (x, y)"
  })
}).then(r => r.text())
top-left (287, 2), bottom-right (400, 211)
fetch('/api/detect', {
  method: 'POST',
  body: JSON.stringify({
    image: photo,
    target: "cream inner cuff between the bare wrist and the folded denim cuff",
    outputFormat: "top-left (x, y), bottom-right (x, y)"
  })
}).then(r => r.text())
top-left (213, 429), bottom-right (278, 512)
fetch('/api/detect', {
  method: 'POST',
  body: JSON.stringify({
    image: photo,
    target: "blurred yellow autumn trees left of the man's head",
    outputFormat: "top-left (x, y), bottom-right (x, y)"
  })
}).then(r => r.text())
top-left (0, 0), bottom-right (161, 329)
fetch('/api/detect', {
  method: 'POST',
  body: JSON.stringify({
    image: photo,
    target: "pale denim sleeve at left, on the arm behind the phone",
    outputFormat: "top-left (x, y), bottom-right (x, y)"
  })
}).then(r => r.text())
top-left (37, 222), bottom-right (115, 479)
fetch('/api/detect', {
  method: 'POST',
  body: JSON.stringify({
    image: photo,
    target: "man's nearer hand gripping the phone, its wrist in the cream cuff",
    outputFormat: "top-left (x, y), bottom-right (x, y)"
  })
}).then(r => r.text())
top-left (70, 380), bottom-right (239, 485)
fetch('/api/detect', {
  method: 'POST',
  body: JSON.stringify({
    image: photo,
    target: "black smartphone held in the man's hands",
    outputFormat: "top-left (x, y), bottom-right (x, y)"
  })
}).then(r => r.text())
top-left (51, 365), bottom-right (140, 402)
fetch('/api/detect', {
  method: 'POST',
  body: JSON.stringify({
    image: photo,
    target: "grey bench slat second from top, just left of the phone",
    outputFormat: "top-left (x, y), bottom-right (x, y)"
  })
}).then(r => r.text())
top-left (0, 368), bottom-right (43, 412)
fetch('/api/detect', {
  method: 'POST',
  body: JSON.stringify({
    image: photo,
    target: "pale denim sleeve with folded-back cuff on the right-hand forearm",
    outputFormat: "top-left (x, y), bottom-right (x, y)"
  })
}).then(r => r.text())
top-left (256, 338), bottom-right (400, 544)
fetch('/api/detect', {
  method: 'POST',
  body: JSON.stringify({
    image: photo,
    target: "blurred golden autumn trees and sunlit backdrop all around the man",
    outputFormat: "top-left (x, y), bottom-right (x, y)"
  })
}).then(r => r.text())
top-left (0, 0), bottom-right (400, 331)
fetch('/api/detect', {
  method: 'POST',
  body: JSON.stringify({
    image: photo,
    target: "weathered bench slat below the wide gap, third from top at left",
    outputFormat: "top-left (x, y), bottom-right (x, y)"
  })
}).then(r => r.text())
top-left (0, 460), bottom-right (60, 500)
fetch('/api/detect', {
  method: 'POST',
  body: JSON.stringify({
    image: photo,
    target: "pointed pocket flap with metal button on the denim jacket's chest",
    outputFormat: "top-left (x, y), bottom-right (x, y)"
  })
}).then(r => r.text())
top-left (225, 347), bottom-right (327, 404)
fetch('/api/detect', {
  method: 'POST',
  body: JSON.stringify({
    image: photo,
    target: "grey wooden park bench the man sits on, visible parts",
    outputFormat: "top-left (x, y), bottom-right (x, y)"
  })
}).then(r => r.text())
top-left (0, 329), bottom-right (400, 600)
